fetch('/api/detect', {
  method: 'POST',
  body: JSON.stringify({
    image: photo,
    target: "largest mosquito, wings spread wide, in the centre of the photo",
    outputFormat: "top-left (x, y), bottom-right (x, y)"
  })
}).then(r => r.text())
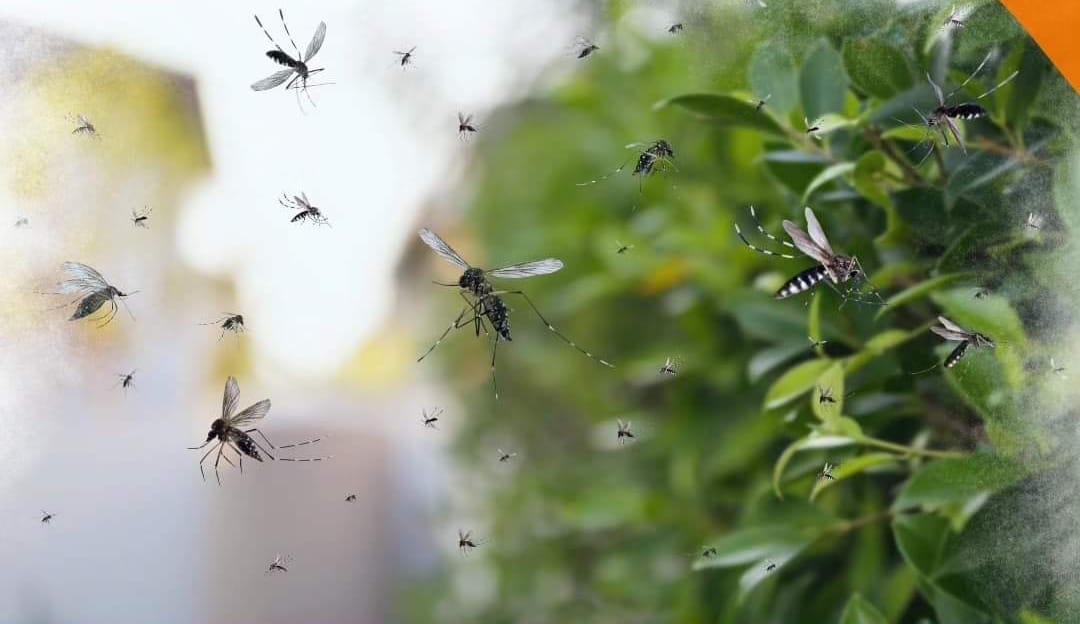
top-left (417, 228), bottom-right (615, 398)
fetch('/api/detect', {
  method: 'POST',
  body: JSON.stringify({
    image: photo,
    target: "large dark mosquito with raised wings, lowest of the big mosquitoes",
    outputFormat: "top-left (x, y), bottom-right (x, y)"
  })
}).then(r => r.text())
top-left (188, 376), bottom-right (330, 485)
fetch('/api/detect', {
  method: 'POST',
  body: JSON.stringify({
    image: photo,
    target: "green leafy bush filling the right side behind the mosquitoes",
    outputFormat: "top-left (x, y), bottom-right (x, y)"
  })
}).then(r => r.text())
top-left (409, 1), bottom-right (1080, 624)
